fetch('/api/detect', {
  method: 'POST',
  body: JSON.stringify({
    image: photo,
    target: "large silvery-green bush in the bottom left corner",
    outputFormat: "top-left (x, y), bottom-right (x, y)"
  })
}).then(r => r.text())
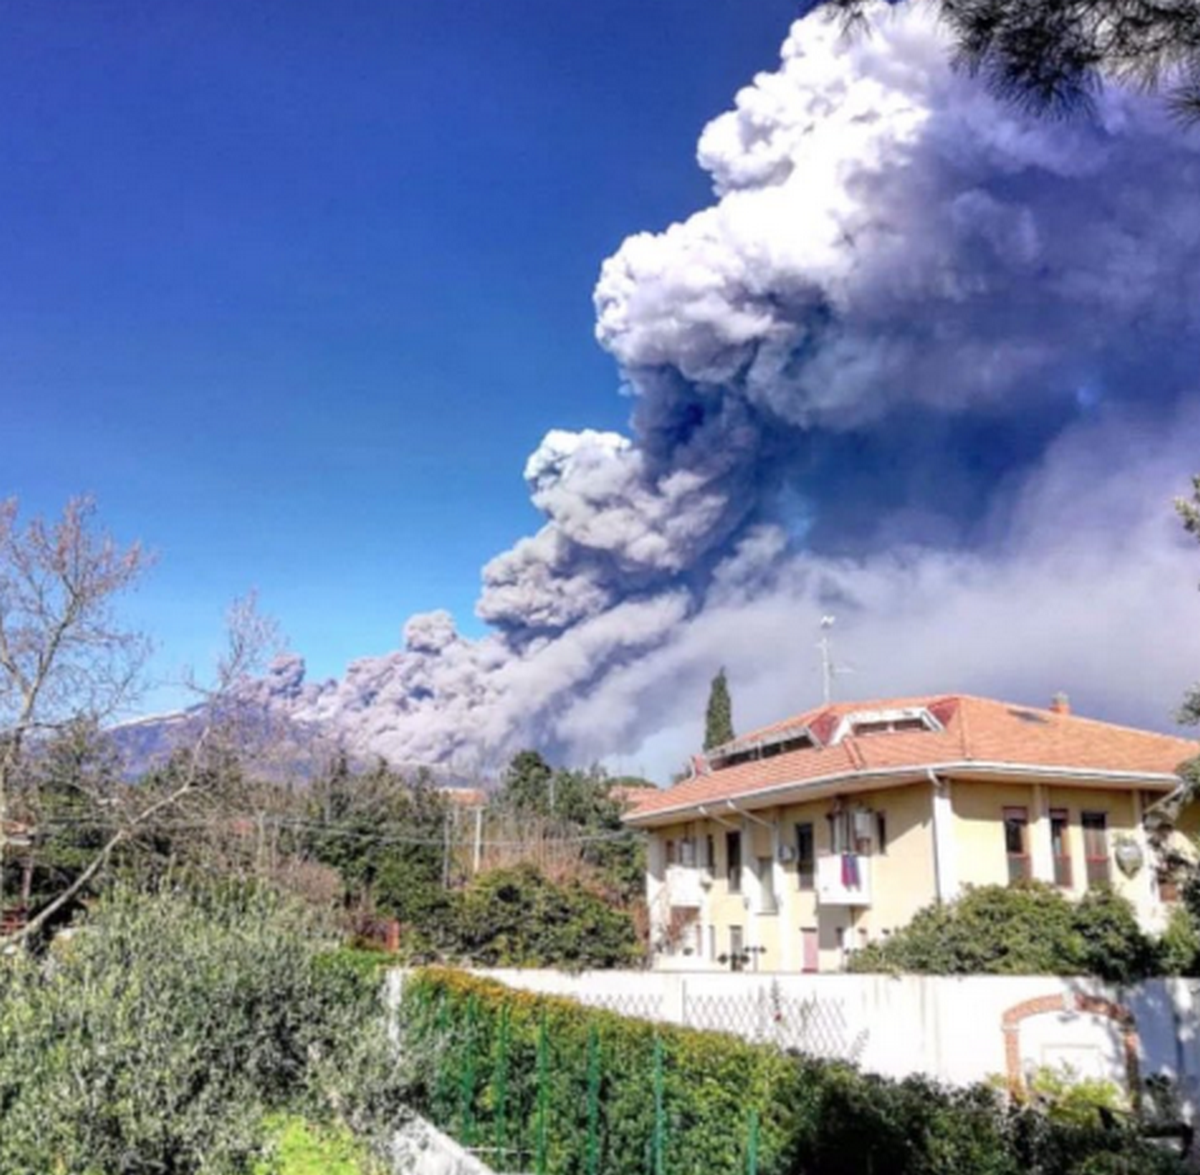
top-left (0, 888), bottom-right (402, 1175)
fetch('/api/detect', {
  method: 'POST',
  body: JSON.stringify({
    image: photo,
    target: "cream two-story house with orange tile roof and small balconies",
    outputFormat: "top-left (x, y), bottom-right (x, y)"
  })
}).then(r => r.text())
top-left (625, 695), bottom-right (1200, 971)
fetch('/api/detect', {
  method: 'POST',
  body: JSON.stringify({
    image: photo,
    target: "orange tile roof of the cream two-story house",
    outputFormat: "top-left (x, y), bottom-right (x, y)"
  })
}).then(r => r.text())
top-left (625, 694), bottom-right (1200, 823)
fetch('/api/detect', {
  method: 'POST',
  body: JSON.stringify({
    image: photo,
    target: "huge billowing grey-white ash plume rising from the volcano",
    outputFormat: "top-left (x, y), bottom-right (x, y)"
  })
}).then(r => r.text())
top-left (267, 6), bottom-right (1200, 769)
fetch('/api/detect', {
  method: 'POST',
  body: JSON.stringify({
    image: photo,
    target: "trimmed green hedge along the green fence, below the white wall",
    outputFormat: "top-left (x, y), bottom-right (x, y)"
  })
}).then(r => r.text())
top-left (403, 969), bottom-right (1184, 1175)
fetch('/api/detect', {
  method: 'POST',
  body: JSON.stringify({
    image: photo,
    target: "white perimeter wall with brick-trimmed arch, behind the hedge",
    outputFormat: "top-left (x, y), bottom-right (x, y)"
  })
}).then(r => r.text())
top-left (448, 970), bottom-right (1200, 1117)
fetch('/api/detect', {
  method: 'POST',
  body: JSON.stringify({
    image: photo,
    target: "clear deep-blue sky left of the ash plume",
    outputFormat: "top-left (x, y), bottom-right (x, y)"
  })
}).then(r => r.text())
top-left (0, 0), bottom-right (798, 696)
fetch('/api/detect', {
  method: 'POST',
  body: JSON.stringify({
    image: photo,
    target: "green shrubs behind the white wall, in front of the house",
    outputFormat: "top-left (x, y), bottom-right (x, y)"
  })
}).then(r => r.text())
top-left (850, 882), bottom-right (1176, 983)
